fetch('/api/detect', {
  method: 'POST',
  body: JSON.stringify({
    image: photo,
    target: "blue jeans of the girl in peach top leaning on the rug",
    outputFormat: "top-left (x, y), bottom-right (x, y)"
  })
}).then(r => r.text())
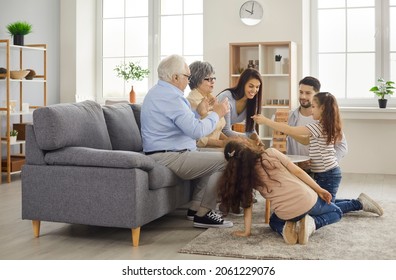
top-left (269, 196), bottom-right (342, 235)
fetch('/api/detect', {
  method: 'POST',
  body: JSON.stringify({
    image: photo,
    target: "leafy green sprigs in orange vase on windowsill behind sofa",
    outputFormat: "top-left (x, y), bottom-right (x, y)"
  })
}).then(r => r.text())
top-left (114, 61), bottom-right (150, 103)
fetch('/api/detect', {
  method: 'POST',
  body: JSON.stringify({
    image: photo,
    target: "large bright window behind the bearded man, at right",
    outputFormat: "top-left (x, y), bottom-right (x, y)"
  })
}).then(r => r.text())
top-left (311, 0), bottom-right (396, 106)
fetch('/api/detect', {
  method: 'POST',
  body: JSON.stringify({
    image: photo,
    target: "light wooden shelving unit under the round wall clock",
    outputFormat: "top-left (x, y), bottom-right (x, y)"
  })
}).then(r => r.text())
top-left (229, 41), bottom-right (298, 147)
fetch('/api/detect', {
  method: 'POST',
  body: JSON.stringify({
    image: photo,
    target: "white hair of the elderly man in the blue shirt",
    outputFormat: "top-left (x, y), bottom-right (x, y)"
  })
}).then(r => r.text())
top-left (157, 54), bottom-right (186, 82)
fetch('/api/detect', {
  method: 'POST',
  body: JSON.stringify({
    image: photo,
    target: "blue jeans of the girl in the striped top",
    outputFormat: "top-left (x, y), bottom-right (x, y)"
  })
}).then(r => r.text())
top-left (313, 167), bottom-right (363, 214)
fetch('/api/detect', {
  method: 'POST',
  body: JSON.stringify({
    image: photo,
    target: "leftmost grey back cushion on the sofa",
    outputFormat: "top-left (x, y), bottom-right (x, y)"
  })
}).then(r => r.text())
top-left (33, 100), bottom-right (112, 150)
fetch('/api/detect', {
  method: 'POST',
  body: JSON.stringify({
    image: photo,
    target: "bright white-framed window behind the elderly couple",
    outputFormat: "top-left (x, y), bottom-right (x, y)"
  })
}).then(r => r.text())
top-left (97, 0), bottom-right (203, 102)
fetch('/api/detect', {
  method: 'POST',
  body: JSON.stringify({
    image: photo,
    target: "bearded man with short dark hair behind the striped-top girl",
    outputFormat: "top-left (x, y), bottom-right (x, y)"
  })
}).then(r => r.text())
top-left (287, 76), bottom-right (348, 173)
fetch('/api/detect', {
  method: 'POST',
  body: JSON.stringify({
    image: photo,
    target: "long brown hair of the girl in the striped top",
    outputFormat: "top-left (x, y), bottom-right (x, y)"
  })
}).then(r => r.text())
top-left (313, 92), bottom-right (342, 145)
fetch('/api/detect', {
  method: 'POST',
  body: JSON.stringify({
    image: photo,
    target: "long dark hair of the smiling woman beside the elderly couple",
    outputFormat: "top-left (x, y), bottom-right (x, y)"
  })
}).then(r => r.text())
top-left (218, 68), bottom-right (263, 131)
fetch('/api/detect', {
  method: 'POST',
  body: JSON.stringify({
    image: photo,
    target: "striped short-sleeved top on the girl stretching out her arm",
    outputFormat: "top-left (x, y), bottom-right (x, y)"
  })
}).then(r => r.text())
top-left (306, 123), bottom-right (338, 173)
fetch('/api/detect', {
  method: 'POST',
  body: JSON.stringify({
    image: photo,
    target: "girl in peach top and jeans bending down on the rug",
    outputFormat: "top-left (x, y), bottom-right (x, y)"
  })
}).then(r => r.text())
top-left (218, 140), bottom-right (342, 244)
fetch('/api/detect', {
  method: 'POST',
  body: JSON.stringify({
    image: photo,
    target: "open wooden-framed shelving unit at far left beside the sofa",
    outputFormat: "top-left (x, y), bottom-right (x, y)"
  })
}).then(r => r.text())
top-left (0, 39), bottom-right (47, 183)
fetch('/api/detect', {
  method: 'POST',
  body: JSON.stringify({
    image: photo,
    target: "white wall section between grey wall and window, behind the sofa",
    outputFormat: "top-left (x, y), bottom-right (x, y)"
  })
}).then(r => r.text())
top-left (60, 0), bottom-right (96, 102)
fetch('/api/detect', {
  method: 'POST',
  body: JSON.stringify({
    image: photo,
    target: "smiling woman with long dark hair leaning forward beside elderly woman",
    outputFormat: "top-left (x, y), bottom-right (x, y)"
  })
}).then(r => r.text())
top-left (217, 68), bottom-right (263, 145)
